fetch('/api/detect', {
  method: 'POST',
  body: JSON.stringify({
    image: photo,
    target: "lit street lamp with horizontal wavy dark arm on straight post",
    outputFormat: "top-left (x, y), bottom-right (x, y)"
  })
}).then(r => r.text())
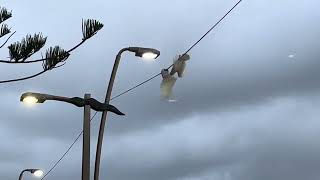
top-left (20, 92), bottom-right (124, 180)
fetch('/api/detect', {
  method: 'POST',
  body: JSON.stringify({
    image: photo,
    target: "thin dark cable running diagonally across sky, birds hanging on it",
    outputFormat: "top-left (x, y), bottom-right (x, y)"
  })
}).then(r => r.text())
top-left (41, 0), bottom-right (242, 180)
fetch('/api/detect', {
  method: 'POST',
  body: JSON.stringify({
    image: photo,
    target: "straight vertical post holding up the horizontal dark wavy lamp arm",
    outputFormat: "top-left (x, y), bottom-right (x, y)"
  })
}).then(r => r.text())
top-left (82, 94), bottom-right (91, 180)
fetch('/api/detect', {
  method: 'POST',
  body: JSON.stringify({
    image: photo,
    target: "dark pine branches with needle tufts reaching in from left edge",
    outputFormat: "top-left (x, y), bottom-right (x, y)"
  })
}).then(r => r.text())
top-left (0, 19), bottom-right (103, 84)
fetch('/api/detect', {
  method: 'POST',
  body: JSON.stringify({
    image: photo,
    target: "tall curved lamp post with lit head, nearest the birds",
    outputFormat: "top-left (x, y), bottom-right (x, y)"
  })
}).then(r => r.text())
top-left (94, 47), bottom-right (160, 180)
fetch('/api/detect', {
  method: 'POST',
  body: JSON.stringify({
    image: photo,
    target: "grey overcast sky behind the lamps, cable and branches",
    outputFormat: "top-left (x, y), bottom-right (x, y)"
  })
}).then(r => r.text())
top-left (0, 0), bottom-right (320, 180)
